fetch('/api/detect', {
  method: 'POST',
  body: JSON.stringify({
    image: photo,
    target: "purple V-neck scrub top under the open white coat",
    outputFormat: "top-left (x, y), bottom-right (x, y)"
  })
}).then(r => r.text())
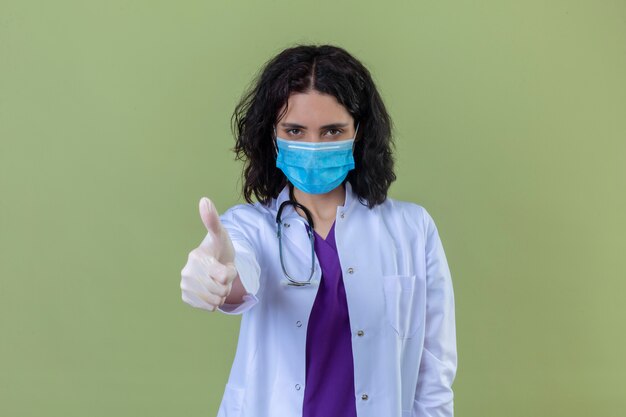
top-left (302, 223), bottom-right (356, 417)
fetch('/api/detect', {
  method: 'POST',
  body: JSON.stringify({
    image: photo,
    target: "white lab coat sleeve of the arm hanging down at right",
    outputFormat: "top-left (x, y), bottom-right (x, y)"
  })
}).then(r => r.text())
top-left (413, 209), bottom-right (457, 417)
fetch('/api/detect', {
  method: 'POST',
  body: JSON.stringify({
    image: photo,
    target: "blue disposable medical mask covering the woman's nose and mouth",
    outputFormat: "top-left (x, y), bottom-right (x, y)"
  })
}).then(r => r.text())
top-left (276, 125), bottom-right (359, 194)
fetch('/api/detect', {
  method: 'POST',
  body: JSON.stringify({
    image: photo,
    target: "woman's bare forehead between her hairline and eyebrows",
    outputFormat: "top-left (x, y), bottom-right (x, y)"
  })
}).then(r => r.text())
top-left (278, 90), bottom-right (352, 126)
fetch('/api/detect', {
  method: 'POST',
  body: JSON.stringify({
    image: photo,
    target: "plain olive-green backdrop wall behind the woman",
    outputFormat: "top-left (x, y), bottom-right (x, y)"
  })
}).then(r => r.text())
top-left (0, 0), bottom-right (626, 417)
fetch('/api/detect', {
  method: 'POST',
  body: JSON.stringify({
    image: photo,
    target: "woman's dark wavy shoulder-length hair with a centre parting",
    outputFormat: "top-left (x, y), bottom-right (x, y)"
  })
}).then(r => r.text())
top-left (231, 45), bottom-right (396, 208)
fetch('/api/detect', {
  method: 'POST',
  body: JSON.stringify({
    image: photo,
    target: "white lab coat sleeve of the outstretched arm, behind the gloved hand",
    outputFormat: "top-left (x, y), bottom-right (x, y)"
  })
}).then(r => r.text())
top-left (211, 208), bottom-right (261, 315)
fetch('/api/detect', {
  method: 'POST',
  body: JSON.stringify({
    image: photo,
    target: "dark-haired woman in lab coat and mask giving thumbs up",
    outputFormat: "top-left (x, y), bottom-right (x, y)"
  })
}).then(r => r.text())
top-left (181, 45), bottom-right (457, 417)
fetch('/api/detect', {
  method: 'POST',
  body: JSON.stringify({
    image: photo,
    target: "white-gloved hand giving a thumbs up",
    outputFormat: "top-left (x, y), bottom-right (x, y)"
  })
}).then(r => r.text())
top-left (180, 197), bottom-right (237, 311)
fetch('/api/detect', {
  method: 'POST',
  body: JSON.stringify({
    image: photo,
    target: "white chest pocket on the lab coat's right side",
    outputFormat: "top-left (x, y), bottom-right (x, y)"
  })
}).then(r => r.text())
top-left (383, 275), bottom-right (421, 339)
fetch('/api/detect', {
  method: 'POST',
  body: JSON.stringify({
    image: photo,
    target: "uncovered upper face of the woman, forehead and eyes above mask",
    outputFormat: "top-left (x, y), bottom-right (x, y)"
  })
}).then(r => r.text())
top-left (276, 90), bottom-right (355, 142)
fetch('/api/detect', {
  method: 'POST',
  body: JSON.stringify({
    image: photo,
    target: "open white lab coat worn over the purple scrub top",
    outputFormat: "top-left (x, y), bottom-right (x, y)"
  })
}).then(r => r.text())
top-left (207, 182), bottom-right (457, 417)
